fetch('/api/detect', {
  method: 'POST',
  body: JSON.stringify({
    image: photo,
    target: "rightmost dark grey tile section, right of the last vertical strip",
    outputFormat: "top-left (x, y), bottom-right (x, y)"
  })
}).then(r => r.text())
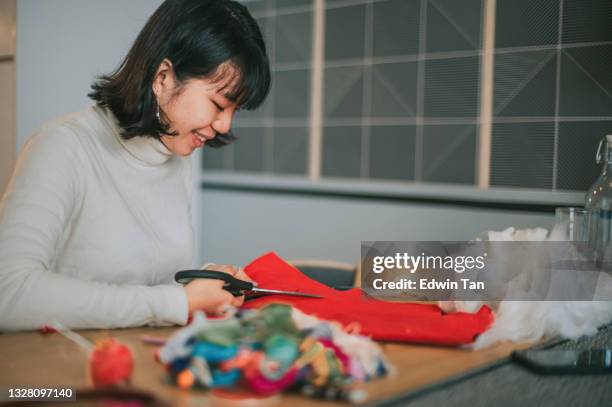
top-left (491, 0), bottom-right (612, 191)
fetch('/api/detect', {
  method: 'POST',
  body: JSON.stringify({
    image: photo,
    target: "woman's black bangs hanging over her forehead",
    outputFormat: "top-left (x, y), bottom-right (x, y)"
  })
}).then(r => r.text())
top-left (208, 55), bottom-right (270, 110)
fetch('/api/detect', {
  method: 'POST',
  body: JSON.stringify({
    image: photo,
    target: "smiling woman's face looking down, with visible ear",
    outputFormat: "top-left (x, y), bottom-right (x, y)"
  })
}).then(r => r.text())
top-left (153, 61), bottom-right (237, 156)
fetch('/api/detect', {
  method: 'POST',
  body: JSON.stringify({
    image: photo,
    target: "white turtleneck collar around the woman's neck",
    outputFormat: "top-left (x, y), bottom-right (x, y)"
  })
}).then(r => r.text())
top-left (95, 106), bottom-right (172, 166)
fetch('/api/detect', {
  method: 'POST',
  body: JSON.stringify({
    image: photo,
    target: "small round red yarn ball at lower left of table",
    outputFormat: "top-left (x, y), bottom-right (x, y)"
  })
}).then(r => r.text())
top-left (89, 338), bottom-right (134, 387)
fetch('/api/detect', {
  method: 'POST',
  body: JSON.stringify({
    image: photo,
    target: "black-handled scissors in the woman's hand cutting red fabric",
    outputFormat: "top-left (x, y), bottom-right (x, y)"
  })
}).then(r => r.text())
top-left (174, 270), bottom-right (323, 298)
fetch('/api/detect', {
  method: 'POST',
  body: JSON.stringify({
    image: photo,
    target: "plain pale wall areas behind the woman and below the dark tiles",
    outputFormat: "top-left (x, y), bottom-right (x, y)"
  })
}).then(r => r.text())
top-left (17, 0), bottom-right (552, 270)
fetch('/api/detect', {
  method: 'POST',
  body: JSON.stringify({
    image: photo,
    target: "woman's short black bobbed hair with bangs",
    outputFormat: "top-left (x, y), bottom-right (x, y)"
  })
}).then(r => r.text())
top-left (88, 0), bottom-right (271, 147)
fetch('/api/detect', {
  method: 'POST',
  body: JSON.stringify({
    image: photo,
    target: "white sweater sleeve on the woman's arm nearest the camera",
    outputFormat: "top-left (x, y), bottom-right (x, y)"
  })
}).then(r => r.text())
top-left (0, 126), bottom-right (188, 330)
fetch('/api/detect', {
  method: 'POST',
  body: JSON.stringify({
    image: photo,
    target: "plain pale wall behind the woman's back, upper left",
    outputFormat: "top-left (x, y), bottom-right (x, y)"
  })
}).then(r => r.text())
top-left (17, 0), bottom-right (161, 150)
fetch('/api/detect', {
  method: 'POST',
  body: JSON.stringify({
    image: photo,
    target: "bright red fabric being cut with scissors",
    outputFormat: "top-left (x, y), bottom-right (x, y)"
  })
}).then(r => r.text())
top-left (244, 253), bottom-right (494, 345)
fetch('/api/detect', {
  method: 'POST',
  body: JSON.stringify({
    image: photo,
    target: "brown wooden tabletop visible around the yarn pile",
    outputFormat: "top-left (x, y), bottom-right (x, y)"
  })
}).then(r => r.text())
top-left (0, 328), bottom-right (529, 407)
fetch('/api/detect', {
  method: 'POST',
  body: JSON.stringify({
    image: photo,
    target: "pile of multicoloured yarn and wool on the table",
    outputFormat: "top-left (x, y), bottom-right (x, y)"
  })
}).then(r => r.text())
top-left (159, 304), bottom-right (390, 402)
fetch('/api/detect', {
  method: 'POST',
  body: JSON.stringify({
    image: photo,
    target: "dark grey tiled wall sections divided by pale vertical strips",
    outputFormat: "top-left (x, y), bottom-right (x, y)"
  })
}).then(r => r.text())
top-left (204, 0), bottom-right (612, 190)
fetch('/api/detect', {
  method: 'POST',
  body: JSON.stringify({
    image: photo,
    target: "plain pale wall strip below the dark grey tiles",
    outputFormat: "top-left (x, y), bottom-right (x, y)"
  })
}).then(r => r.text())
top-left (199, 190), bottom-right (553, 264)
